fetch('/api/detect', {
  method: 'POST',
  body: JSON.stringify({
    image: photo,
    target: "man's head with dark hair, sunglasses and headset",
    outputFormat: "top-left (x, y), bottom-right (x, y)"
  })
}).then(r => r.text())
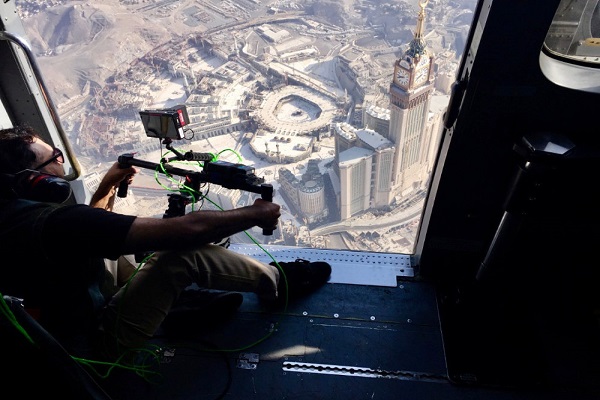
top-left (0, 125), bottom-right (71, 203)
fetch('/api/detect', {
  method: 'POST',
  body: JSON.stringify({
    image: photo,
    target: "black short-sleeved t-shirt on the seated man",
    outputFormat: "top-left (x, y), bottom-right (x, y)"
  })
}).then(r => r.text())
top-left (0, 199), bottom-right (136, 354)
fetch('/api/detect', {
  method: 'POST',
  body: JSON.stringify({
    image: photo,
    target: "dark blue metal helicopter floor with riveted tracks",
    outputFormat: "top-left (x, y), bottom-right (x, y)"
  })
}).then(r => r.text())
top-left (96, 282), bottom-right (596, 400)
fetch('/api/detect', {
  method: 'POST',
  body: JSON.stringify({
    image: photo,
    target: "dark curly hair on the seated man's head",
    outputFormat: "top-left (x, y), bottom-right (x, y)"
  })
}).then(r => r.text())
top-left (0, 124), bottom-right (40, 174)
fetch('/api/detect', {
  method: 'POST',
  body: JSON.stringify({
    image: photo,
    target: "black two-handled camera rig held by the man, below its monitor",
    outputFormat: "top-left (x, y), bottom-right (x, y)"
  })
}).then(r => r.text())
top-left (117, 138), bottom-right (273, 235)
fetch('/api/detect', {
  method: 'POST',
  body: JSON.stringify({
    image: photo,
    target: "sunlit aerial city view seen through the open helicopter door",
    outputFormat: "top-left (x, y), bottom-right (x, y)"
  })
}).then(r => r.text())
top-left (17, 0), bottom-right (475, 253)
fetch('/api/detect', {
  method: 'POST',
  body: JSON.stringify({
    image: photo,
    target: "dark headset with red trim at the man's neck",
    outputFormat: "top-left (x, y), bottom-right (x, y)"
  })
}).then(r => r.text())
top-left (0, 169), bottom-right (73, 204)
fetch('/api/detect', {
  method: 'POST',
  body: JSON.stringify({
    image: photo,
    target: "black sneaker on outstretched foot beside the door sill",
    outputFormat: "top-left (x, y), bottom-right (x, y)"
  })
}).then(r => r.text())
top-left (271, 258), bottom-right (331, 298)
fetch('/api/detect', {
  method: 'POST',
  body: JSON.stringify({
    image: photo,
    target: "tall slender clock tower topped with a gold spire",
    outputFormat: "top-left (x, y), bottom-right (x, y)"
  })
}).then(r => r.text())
top-left (389, 0), bottom-right (433, 195)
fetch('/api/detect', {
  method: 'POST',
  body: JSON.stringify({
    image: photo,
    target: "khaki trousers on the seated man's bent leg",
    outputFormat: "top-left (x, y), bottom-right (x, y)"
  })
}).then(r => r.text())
top-left (102, 244), bottom-right (279, 349)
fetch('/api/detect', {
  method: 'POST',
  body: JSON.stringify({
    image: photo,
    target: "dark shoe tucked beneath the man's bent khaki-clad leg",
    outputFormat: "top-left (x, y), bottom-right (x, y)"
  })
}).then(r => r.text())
top-left (162, 289), bottom-right (244, 334)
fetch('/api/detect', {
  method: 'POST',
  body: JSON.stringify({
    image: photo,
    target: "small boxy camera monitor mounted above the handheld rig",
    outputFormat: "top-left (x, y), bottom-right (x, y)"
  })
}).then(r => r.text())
top-left (140, 105), bottom-right (190, 140)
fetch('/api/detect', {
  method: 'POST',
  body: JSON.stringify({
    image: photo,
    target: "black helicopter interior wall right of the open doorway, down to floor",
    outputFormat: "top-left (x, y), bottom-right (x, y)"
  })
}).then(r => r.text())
top-left (417, 1), bottom-right (600, 387)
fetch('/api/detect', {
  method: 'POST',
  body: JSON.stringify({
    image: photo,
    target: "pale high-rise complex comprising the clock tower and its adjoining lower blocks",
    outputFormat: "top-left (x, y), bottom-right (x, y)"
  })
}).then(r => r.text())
top-left (332, 0), bottom-right (440, 220)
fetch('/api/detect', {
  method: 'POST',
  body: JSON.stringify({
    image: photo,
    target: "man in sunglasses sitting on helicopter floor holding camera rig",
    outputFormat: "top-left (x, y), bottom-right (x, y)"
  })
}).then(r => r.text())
top-left (0, 126), bottom-right (331, 356)
